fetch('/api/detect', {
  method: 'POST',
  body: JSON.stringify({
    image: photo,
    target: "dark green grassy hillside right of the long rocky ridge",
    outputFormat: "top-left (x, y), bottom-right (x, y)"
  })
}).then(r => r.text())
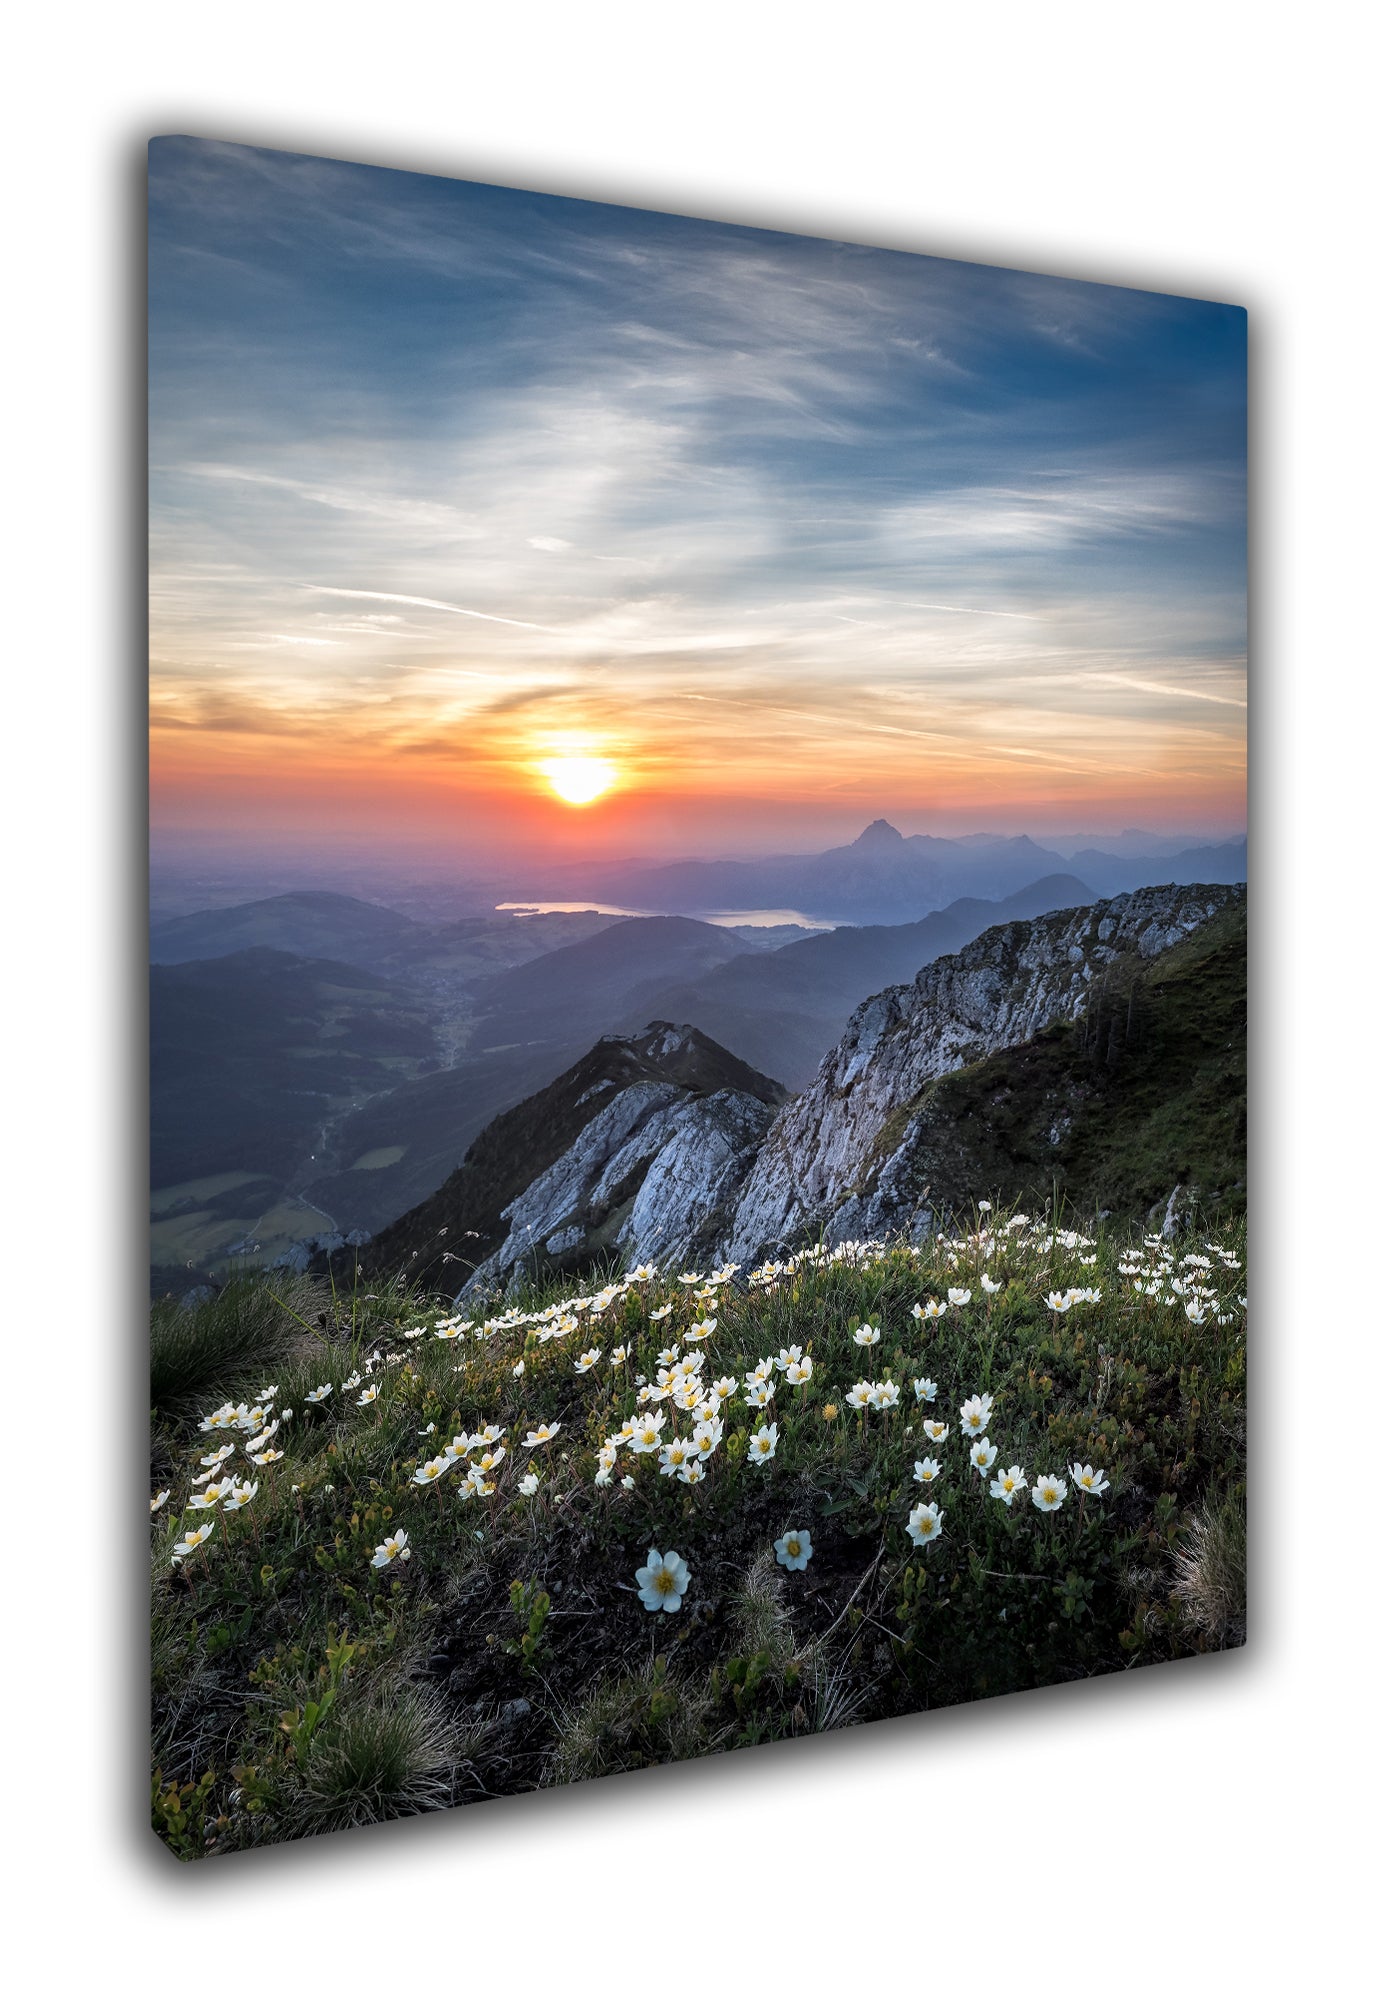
top-left (873, 904), bottom-right (1246, 1217)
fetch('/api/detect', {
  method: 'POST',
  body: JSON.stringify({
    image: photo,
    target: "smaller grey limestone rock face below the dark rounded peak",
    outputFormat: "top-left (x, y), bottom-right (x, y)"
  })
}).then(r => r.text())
top-left (463, 1081), bottom-right (774, 1299)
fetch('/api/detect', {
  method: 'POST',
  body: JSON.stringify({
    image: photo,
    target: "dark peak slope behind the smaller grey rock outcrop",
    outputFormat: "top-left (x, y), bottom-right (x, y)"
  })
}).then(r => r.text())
top-left (363, 1023), bottom-right (784, 1287)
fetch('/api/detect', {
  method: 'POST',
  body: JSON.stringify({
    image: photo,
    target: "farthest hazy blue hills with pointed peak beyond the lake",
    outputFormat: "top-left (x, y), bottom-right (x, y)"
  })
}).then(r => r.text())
top-left (538, 818), bottom-right (1244, 924)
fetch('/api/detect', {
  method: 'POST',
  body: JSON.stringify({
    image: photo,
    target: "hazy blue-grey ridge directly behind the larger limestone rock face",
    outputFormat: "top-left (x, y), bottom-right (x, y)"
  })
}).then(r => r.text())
top-left (620, 874), bottom-right (1099, 1089)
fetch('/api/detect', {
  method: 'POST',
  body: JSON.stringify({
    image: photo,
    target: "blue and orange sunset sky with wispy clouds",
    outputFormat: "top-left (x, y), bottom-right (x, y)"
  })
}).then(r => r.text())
top-left (150, 138), bottom-right (1246, 864)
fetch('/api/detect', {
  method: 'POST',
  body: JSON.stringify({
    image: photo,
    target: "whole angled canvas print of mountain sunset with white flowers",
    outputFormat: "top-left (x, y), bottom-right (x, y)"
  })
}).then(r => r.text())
top-left (150, 138), bottom-right (1246, 1859)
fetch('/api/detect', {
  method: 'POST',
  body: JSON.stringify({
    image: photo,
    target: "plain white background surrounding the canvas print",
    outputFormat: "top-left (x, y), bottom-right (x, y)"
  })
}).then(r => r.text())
top-left (0, 0), bottom-right (1380, 1991)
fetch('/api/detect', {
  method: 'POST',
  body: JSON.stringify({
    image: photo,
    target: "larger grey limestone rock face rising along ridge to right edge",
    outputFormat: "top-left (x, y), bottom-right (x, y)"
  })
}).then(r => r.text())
top-left (722, 886), bottom-right (1244, 1265)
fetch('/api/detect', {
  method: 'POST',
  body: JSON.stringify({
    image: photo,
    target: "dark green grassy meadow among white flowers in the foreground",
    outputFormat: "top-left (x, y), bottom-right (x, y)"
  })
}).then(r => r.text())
top-left (152, 1215), bottom-right (1244, 1857)
